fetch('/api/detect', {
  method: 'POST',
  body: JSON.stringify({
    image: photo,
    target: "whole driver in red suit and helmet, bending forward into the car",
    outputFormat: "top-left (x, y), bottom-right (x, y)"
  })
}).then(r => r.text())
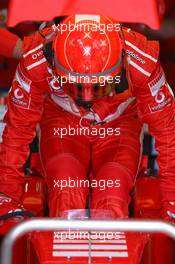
top-left (0, 15), bottom-right (175, 220)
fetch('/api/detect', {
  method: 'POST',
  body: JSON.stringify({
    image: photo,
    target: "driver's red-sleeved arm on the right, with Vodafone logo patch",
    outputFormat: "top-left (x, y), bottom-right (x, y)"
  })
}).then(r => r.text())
top-left (137, 63), bottom-right (175, 221)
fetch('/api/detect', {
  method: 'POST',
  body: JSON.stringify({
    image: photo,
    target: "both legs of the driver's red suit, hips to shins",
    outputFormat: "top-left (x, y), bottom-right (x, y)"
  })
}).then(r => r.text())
top-left (41, 106), bottom-right (141, 217)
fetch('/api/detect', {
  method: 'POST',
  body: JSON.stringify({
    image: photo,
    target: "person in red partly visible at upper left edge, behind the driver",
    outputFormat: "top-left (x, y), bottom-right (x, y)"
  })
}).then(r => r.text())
top-left (0, 0), bottom-right (38, 87)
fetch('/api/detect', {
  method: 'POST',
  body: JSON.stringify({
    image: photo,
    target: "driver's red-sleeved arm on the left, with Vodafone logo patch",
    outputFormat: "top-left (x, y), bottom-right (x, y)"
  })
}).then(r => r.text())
top-left (0, 59), bottom-right (44, 201)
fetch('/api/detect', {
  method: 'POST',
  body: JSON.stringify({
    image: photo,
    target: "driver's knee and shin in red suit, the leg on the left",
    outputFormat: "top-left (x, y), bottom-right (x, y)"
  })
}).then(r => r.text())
top-left (45, 153), bottom-right (88, 217)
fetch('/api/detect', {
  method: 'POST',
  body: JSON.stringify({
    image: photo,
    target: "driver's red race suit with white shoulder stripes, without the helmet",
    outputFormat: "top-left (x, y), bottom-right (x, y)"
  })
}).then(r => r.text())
top-left (0, 29), bottom-right (175, 217)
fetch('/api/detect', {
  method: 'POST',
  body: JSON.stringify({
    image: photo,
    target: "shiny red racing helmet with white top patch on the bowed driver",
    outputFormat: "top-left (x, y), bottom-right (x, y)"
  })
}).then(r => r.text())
top-left (53, 15), bottom-right (123, 105)
